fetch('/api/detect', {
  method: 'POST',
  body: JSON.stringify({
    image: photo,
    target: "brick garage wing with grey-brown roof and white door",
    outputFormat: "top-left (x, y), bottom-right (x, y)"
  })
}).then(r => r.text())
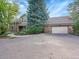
top-left (44, 16), bottom-right (73, 34)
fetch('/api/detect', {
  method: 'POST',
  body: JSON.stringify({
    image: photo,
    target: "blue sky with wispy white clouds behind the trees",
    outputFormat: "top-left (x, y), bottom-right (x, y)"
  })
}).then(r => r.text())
top-left (16, 0), bottom-right (72, 17)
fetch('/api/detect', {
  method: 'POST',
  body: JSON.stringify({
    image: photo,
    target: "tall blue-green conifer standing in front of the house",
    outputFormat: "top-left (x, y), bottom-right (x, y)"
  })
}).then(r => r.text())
top-left (27, 0), bottom-right (48, 33)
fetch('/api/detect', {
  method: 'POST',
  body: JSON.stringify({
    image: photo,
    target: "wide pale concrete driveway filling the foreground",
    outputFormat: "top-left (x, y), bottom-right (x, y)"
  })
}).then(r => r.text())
top-left (0, 34), bottom-right (79, 59)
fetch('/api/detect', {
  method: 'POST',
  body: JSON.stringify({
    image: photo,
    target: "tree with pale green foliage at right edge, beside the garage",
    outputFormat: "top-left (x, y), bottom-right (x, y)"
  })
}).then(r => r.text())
top-left (68, 0), bottom-right (79, 35)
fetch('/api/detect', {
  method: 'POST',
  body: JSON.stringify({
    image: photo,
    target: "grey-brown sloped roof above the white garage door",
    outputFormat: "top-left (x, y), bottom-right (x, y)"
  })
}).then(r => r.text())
top-left (47, 16), bottom-right (73, 25)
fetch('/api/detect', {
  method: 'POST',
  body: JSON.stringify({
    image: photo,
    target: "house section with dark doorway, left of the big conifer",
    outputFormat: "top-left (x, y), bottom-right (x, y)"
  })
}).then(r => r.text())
top-left (11, 14), bottom-right (27, 32)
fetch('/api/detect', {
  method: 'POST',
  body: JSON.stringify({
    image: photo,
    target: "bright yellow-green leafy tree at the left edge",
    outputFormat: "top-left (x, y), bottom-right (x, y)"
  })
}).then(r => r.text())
top-left (0, 0), bottom-right (18, 34)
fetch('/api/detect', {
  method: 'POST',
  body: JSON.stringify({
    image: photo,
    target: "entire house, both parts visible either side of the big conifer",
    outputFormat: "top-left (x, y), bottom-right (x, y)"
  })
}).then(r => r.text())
top-left (13, 15), bottom-right (73, 33)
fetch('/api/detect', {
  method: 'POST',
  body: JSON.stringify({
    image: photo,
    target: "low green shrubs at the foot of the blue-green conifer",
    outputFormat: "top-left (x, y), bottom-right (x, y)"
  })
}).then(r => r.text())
top-left (16, 26), bottom-right (43, 35)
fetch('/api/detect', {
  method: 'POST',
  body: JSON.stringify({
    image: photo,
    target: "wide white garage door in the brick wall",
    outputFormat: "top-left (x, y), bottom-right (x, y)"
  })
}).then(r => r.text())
top-left (52, 27), bottom-right (68, 34)
